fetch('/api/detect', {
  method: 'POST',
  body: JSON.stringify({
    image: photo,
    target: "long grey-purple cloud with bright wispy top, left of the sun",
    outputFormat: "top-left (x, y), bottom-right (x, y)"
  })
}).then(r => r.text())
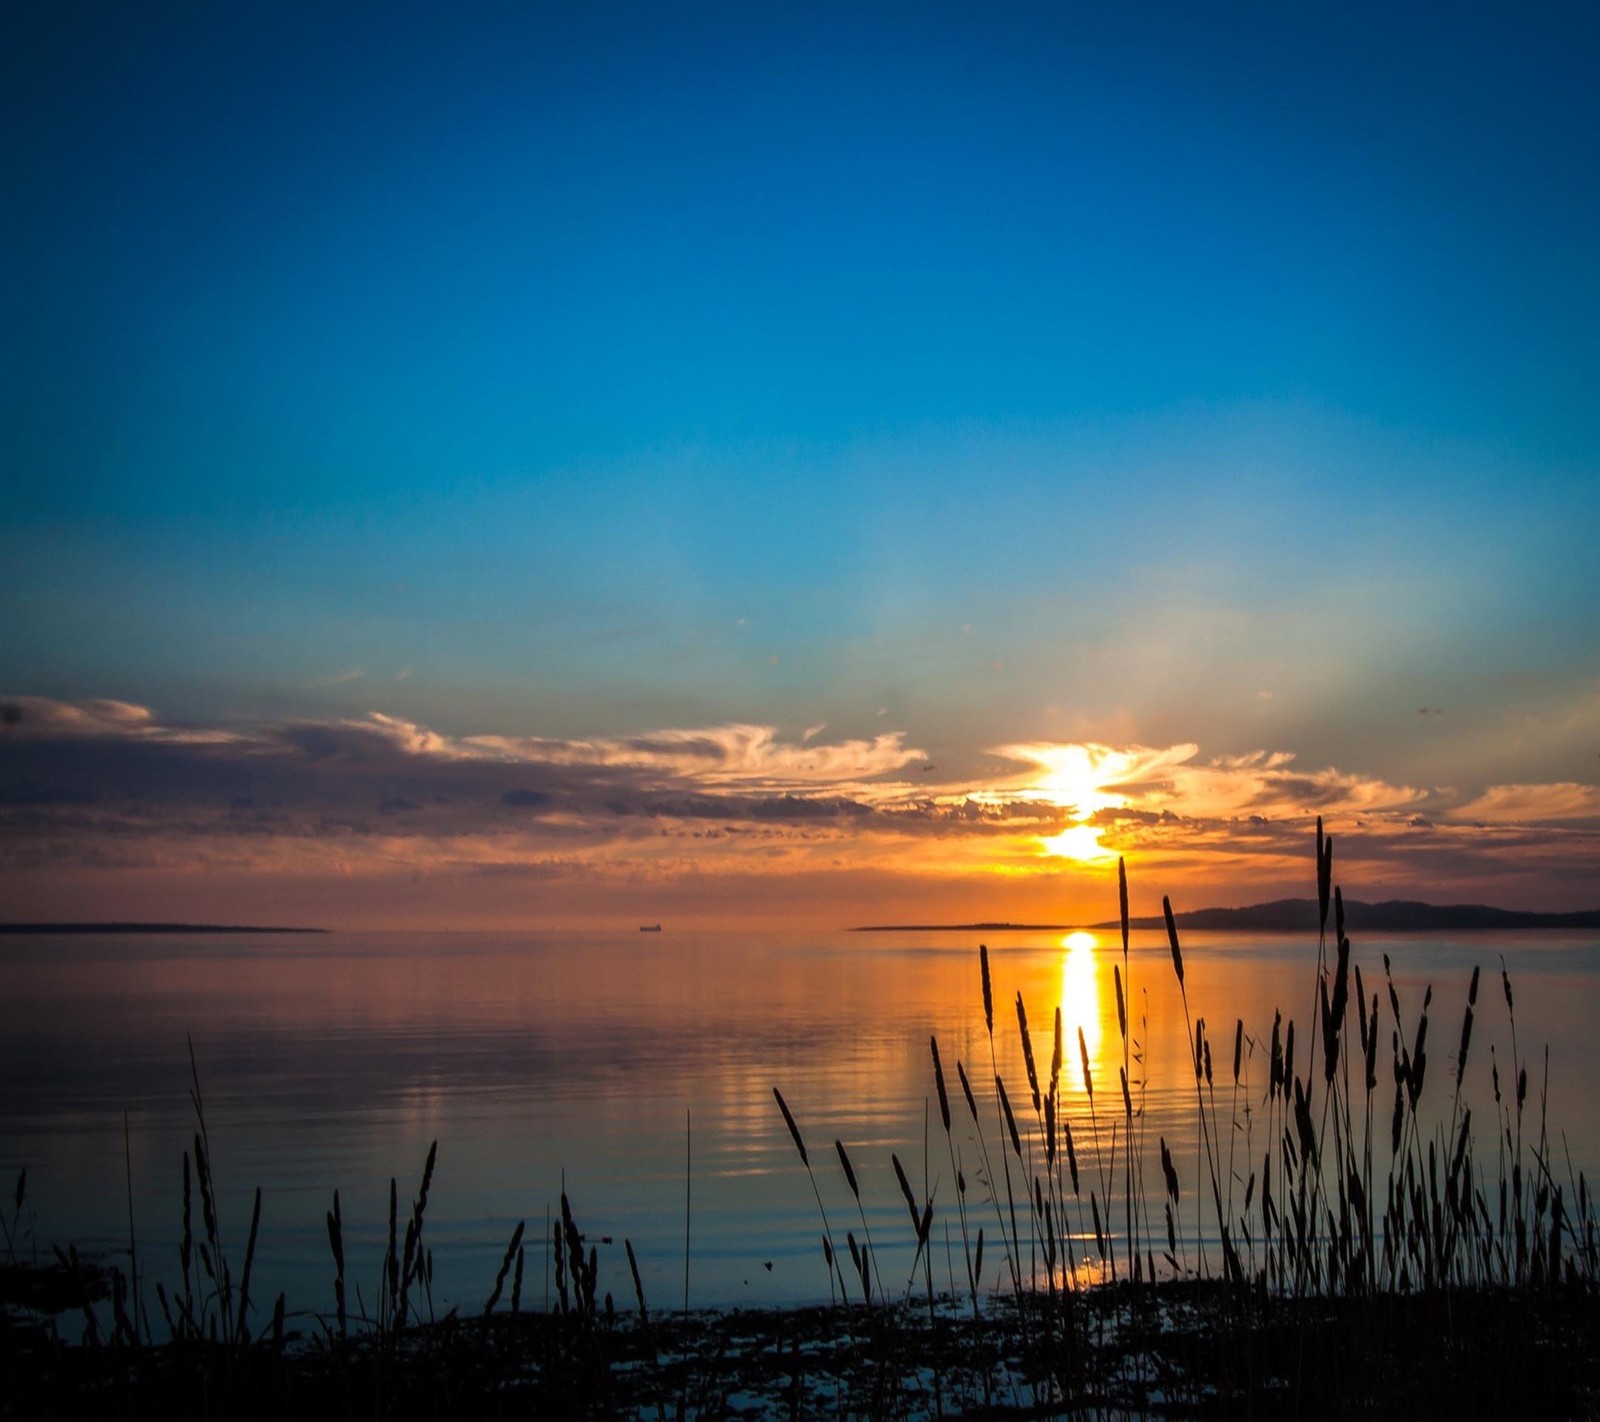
top-left (0, 697), bottom-right (923, 837)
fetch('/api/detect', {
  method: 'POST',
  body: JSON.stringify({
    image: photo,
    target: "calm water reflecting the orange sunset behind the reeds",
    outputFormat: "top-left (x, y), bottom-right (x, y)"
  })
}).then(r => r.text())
top-left (0, 931), bottom-right (1600, 1312)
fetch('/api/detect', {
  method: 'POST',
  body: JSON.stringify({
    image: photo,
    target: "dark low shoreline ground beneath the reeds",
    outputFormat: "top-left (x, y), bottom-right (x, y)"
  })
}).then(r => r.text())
top-left (0, 1280), bottom-right (1600, 1422)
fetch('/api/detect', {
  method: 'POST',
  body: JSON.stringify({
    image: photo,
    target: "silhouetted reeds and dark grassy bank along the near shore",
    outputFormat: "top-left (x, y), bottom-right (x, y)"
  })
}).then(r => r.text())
top-left (0, 821), bottom-right (1600, 1422)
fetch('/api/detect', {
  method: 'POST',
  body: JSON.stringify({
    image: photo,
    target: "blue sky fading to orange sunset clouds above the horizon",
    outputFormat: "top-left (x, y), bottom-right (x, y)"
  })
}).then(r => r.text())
top-left (0, 3), bottom-right (1600, 928)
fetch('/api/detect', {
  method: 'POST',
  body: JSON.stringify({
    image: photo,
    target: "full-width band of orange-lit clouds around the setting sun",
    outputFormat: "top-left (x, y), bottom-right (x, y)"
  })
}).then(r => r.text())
top-left (0, 697), bottom-right (1600, 920)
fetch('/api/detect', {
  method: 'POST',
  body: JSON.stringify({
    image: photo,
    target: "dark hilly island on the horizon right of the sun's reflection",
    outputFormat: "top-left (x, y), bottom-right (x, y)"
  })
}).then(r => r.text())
top-left (851, 899), bottom-right (1600, 933)
